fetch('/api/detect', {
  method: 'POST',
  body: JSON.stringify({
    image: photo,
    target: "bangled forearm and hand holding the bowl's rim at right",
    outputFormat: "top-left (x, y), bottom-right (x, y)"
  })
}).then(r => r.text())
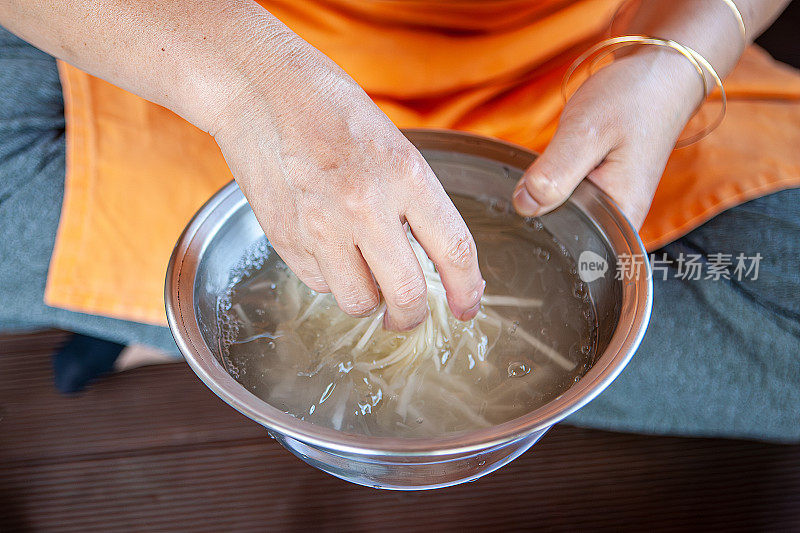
top-left (513, 0), bottom-right (788, 224)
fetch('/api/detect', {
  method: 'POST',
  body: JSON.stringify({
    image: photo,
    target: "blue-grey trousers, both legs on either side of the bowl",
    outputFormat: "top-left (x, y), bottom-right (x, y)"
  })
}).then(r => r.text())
top-left (0, 28), bottom-right (800, 441)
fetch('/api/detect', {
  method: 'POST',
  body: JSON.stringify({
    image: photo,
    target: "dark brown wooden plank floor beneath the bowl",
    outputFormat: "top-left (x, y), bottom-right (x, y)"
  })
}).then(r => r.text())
top-left (0, 332), bottom-right (800, 531)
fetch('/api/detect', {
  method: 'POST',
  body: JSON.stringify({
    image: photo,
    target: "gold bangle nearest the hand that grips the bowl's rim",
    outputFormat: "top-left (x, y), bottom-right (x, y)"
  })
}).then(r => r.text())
top-left (561, 35), bottom-right (727, 148)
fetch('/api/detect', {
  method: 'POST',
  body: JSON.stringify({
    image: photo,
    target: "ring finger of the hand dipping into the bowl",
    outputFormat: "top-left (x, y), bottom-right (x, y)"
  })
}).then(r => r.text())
top-left (316, 244), bottom-right (380, 317)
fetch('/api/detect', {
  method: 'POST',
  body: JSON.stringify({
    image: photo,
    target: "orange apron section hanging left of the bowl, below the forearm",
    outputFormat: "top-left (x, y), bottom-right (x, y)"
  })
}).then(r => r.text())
top-left (45, 63), bottom-right (231, 324)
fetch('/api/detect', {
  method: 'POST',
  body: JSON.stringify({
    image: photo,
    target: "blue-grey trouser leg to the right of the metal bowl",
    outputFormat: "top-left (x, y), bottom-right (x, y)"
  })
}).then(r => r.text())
top-left (570, 189), bottom-right (800, 441)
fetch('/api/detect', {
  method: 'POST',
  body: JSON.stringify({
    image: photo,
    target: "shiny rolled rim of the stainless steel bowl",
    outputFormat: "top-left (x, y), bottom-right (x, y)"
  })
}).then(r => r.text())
top-left (165, 129), bottom-right (653, 457)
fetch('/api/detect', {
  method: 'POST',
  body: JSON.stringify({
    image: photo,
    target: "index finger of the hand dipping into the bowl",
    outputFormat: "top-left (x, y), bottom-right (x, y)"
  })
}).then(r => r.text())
top-left (405, 178), bottom-right (486, 320)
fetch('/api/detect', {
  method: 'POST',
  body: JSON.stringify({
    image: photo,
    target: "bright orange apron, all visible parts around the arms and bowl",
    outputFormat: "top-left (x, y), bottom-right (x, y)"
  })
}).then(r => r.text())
top-left (45, 0), bottom-right (800, 324)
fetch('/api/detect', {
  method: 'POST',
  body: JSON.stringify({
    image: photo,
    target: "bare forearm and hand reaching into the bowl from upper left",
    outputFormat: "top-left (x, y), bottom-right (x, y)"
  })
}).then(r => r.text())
top-left (0, 0), bottom-right (484, 330)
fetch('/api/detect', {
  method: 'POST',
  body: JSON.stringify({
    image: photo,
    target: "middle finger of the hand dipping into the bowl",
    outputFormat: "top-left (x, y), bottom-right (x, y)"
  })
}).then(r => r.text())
top-left (359, 219), bottom-right (428, 331)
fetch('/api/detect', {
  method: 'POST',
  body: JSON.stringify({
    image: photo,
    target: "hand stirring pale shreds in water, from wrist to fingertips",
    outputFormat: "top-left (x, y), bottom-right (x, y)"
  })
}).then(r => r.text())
top-left (208, 33), bottom-right (485, 330)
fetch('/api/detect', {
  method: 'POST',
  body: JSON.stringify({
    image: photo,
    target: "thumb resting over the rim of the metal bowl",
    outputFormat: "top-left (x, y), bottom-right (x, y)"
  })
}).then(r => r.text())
top-left (512, 116), bottom-right (611, 216)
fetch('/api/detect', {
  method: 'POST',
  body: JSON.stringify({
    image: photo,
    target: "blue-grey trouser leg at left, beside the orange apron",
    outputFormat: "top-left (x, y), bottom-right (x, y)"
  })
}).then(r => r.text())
top-left (0, 27), bottom-right (177, 354)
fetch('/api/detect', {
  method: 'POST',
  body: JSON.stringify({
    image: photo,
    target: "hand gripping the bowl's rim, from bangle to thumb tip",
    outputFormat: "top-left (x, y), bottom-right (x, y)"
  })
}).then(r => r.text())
top-left (513, 47), bottom-right (703, 229)
